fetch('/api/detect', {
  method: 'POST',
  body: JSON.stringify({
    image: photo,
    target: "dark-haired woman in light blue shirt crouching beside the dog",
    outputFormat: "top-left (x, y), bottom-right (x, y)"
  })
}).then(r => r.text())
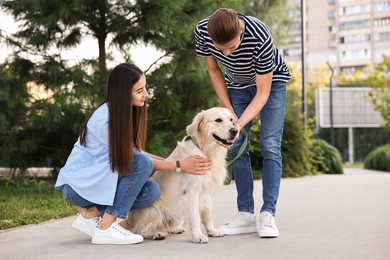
top-left (55, 63), bottom-right (211, 244)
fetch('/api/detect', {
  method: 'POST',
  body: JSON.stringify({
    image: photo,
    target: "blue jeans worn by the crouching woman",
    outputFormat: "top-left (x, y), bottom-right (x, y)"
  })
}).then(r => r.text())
top-left (61, 153), bottom-right (160, 219)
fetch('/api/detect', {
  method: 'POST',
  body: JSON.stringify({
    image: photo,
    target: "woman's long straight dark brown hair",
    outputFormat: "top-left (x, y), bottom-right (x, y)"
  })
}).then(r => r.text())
top-left (80, 63), bottom-right (147, 175)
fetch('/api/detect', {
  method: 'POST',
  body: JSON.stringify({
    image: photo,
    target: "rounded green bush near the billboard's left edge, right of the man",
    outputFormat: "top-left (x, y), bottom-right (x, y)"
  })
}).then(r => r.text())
top-left (311, 139), bottom-right (344, 174)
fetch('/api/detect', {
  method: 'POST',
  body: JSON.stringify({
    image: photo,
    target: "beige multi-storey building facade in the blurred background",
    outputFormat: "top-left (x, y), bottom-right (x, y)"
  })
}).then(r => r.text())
top-left (281, 0), bottom-right (390, 78)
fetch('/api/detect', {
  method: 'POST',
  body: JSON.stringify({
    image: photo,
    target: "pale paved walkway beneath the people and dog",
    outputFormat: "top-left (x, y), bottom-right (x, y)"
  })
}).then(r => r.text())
top-left (0, 169), bottom-right (390, 260)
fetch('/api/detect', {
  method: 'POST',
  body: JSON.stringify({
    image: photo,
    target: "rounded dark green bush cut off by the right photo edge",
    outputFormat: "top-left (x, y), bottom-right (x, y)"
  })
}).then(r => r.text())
top-left (363, 144), bottom-right (390, 172)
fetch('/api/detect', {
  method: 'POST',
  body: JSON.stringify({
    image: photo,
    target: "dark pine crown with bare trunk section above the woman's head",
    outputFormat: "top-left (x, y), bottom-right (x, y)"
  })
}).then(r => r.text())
top-left (1, 0), bottom-right (185, 70)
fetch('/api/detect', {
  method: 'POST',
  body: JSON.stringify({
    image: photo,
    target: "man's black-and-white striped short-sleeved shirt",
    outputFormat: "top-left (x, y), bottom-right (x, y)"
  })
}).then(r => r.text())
top-left (195, 15), bottom-right (291, 88)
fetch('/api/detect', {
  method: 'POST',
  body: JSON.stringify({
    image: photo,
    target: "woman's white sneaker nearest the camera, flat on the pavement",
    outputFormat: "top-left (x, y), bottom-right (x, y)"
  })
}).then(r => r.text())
top-left (92, 222), bottom-right (144, 245)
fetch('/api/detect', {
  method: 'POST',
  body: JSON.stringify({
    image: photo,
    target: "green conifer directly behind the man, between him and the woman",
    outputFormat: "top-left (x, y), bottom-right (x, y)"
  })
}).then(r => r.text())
top-left (148, 0), bottom-right (292, 155)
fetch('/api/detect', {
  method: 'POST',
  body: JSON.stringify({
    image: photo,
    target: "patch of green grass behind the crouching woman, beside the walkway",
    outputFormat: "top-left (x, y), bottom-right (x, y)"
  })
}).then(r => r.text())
top-left (0, 177), bottom-right (78, 230)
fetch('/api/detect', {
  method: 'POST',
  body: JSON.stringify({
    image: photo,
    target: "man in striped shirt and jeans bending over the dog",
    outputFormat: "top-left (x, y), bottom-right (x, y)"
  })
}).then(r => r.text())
top-left (195, 8), bottom-right (290, 237)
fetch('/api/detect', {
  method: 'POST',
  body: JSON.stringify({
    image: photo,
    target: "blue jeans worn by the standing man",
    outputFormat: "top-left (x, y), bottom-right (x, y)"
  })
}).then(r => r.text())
top-left (228, 82), bottom-right (286, 214)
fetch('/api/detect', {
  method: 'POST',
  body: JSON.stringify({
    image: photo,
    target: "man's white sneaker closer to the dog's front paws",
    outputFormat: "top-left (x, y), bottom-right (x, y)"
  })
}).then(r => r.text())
top-left (218, 212), bottom-right (257, 235)
